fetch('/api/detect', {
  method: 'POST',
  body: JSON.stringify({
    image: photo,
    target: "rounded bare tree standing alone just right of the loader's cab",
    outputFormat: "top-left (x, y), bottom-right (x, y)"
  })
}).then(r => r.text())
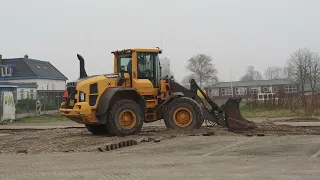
top-left (186, 54), bottom-right (218, 88)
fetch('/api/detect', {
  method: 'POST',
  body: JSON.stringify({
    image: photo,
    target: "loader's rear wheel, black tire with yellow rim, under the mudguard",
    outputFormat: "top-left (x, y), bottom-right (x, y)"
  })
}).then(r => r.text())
top-left (106, 99), bottom-right (144, 136)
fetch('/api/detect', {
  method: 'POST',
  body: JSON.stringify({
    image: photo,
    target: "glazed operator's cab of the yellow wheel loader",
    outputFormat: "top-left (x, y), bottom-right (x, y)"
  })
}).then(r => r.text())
top-left (113, 48), bottom-right (161, 88)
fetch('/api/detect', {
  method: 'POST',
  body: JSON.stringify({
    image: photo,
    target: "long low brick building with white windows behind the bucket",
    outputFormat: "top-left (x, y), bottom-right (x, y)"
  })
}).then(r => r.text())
top-left (205, 79), bottom-right (299, 100)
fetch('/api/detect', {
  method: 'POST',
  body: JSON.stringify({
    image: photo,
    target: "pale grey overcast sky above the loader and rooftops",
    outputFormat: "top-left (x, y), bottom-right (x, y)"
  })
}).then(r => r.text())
top-left (0, 0), bottom-right (320, 81)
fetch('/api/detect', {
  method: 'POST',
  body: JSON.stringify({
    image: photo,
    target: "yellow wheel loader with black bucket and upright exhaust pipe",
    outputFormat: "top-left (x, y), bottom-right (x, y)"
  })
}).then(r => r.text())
top-left (59, 48), bottom-right (256, 136)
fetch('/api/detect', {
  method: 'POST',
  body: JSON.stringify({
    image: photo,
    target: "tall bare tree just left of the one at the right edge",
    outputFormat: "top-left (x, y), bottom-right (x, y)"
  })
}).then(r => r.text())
top-left (287, 48), bottom-right (312, 93)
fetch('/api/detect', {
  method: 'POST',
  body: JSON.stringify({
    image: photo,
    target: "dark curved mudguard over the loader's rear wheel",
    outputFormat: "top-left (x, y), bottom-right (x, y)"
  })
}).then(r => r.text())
top-left (96, 88), bottom-right (146, 124)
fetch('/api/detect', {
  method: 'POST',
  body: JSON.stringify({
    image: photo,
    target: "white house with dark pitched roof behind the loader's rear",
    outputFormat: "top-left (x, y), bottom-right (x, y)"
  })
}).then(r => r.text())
top-left (0, 55), bottom-right (67, 101)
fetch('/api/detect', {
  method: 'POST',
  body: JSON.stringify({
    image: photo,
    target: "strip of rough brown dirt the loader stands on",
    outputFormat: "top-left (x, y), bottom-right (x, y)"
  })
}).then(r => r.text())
top-left (0, 118), bottom-right (320, 154)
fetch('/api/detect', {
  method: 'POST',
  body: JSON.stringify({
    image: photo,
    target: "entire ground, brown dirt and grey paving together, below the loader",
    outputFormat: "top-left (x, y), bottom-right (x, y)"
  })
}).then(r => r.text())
top-left (0, 118), bottom-right (320, 180)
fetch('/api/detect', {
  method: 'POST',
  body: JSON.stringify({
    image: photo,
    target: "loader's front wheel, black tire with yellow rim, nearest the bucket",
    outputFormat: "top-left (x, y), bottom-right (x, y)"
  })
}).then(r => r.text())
top-left (164, 97), bottom-right (204, 130)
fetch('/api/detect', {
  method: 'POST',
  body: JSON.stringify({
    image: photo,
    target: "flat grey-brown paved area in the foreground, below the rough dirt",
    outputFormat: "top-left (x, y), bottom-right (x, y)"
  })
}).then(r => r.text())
top-left (0, 135), bottom-right (320, 180)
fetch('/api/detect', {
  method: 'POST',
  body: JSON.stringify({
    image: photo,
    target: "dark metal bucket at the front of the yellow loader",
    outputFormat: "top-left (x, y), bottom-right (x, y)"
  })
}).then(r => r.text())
top-left (223, 98), bottom-right (257, 131)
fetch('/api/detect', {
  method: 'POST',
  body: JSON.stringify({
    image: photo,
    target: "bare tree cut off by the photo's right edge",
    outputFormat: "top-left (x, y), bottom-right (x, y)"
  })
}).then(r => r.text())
top-left (308, 53), bottom-right (320, 107)
